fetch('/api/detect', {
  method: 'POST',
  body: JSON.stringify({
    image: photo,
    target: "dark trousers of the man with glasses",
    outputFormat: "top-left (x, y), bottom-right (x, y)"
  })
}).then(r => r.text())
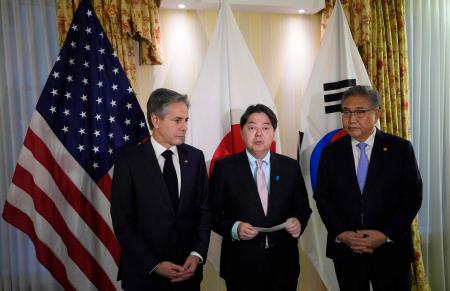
top-left (333, 252), bottom-right (411, 291)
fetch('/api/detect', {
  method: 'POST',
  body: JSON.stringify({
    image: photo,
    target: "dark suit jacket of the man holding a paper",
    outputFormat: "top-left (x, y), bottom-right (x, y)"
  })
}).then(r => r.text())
top-left (210, 151), bottom-right (311, 282)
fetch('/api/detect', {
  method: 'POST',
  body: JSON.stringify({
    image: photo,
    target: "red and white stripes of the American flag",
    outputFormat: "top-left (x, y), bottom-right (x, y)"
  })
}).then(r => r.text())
top-left (3, 111), bottom-right (120, 290)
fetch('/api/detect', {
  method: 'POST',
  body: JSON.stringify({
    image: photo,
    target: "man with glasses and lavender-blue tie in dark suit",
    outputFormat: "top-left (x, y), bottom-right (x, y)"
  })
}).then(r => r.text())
top-left (314, 86), bottom-right (422, 291)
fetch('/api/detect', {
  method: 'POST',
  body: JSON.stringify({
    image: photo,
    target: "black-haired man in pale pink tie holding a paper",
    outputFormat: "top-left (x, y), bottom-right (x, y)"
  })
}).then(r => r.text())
top-left (210, 104), bottom-right (311, 291)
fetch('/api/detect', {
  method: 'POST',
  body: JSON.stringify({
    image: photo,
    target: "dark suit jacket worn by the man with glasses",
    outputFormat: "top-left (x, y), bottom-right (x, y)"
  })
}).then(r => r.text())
top-left (314, 130), bottom-right (422, 260)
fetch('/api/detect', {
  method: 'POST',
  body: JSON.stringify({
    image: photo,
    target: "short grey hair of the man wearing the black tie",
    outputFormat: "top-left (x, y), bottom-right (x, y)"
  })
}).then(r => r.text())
top-left (147, 88), bottom-right (189, 129)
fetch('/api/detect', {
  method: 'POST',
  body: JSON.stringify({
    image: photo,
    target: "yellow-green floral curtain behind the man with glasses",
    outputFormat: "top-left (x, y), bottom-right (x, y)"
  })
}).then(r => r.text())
top-left (322, 0), bottom-right (431, 291)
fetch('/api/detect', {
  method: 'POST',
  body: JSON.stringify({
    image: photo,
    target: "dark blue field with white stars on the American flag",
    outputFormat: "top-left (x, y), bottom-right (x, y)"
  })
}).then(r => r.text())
top-left (36, 5), bottom-right (149, 181)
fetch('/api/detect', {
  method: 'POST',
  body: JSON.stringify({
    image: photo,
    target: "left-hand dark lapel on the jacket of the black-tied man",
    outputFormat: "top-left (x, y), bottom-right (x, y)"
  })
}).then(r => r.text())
top-left (144, 141), bottom-right (174, 211)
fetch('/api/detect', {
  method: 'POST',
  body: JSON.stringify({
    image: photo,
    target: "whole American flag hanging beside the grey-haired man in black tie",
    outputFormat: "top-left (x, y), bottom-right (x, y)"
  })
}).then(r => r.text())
top-left (3, 1), bottom-right (149, 290)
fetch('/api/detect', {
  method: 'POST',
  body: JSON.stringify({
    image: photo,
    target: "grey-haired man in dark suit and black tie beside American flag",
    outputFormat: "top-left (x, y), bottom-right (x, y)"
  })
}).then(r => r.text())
top-left (111, 89), bottom-right (211, 291)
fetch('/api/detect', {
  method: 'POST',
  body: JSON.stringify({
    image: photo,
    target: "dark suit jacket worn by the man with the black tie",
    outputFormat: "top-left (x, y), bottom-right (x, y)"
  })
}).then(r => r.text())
top-left (111, 141), bottom-right (211, 290)
